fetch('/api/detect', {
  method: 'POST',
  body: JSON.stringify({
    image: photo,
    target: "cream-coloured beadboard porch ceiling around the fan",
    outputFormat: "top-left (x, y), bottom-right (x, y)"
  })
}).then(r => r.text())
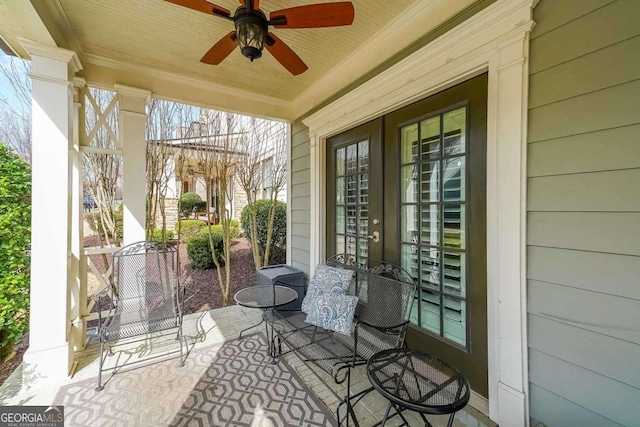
top-left (0, 0), bottom-right (475, 120)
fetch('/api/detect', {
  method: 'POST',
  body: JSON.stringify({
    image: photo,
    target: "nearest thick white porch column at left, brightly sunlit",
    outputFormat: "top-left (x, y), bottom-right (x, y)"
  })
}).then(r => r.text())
top-left (20, 40), bottom-right (81, 387)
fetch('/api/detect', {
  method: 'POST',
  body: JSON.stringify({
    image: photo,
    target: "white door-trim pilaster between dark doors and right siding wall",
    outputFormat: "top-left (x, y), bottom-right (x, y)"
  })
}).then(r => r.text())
top-left (487, 30), bottom-right (531, 426)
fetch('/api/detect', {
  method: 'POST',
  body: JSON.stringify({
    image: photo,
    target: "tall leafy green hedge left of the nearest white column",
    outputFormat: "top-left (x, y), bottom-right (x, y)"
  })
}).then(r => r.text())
top-left (0, 144), bottom-right (31, 362)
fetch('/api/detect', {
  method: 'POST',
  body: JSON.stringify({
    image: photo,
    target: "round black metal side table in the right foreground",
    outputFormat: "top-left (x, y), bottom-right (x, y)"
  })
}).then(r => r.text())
top-left (367, 348), bottom-right (471, 427)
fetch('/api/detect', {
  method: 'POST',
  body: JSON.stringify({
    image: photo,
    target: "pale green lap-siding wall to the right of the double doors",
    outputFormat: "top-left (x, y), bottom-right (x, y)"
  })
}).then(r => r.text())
top-left (527, 0), bottom-right (640, 426)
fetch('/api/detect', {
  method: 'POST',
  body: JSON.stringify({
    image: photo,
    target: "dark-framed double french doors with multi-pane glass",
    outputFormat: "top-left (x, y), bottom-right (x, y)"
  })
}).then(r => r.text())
top-left (326, 75), bottom-right (488, 396)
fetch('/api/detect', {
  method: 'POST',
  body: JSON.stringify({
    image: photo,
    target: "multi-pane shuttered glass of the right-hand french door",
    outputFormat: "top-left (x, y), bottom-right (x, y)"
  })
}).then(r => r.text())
top-left (400, 107), bottom-right (467, 347)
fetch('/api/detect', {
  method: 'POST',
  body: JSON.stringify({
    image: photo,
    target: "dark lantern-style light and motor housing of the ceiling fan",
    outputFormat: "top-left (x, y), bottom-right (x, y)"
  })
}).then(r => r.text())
top-left (233, 6), bottom-right (268, 61)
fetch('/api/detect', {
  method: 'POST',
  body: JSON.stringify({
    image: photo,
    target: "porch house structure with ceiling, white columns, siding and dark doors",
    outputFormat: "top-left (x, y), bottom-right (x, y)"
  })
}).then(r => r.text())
top-left (6, 0), bottom-right (640, 427)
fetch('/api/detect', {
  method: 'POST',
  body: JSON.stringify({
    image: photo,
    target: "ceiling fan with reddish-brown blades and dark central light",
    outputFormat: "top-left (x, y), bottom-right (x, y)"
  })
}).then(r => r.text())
top-left (165, 0), bottom-right (354, 76)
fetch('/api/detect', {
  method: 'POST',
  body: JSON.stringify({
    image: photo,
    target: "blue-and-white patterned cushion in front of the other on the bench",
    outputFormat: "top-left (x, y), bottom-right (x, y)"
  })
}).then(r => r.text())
top-left (307, 288), bottom-right (358, 336)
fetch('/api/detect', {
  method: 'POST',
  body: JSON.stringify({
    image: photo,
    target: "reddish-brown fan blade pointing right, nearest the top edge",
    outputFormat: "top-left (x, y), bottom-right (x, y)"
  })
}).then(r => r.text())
top-left (269, 1), bottom-right (355, 28)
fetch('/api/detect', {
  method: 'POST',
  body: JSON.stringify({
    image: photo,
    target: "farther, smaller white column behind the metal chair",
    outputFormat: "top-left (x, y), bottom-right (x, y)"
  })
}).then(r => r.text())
top-left (115, 85), bottom-right (151, 245)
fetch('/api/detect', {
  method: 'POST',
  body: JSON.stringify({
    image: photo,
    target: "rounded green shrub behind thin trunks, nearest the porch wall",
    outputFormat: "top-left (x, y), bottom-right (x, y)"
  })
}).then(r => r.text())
top-left (240, 200), bottom-right (287, 252)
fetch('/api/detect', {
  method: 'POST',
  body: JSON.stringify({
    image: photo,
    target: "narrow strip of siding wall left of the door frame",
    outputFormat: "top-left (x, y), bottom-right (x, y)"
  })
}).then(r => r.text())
top-left (288, 121), bottom-right (311, 275)
